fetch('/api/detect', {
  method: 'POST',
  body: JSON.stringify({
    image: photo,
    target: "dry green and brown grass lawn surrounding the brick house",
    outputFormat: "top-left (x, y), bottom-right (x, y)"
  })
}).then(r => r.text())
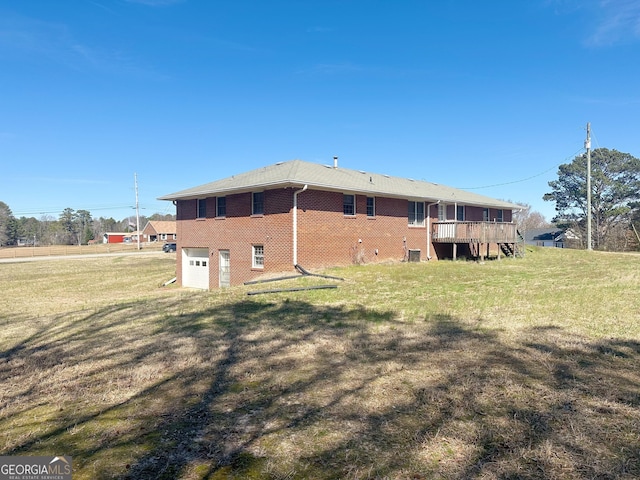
top-left (0, 249), bottom-right (640, 480)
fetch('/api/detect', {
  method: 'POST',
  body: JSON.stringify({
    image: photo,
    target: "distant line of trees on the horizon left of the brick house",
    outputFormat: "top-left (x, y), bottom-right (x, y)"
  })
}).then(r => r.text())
top-left (0, 201), bottom-right (176, 247)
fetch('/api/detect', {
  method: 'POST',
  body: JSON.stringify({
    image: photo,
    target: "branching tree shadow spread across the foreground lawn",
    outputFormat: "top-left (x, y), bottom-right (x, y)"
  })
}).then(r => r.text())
top-left (0, 296), bottom-right (640, 479)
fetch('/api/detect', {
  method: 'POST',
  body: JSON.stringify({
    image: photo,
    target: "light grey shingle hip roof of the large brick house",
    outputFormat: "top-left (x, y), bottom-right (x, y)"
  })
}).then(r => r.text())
top-left (159, 160), bottom-right (520, 209)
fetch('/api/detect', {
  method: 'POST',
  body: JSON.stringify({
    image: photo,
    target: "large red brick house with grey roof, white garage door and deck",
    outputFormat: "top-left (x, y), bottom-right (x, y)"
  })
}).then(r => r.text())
top-left (160, 158), bottom-right (520, 289)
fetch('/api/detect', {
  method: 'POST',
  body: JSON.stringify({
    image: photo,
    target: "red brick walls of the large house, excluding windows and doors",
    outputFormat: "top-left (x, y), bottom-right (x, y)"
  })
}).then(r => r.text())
top-left (177, 188), bottom-right (511, 288)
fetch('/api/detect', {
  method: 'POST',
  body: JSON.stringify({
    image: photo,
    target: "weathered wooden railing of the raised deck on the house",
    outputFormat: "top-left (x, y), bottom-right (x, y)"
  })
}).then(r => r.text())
top-left (431, 222), bottom-right (518, 243)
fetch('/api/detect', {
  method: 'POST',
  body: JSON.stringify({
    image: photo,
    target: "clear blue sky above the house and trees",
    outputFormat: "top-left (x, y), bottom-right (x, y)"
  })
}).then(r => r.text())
top-left (0, 0), bottom-right (640, 220)
